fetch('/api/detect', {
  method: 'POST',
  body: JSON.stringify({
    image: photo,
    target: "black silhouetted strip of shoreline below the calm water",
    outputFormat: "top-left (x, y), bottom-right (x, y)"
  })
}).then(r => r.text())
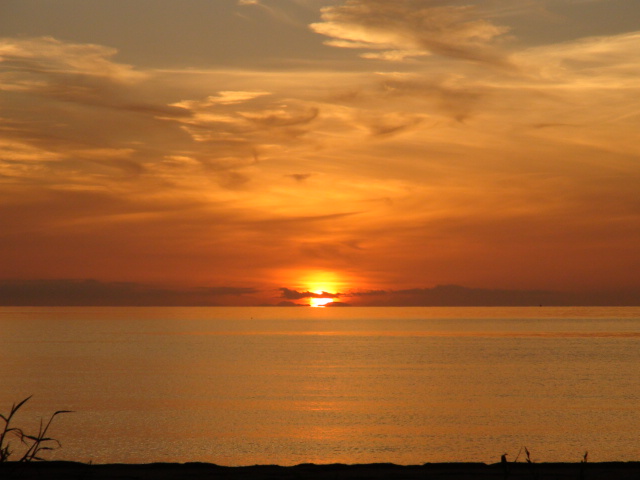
top-left (0, 461), bottom-right (640, 480)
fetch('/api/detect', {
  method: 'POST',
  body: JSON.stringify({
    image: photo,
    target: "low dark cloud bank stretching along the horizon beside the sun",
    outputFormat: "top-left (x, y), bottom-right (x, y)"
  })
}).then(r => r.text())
top-left (0, 279), bottom-right (638, 307)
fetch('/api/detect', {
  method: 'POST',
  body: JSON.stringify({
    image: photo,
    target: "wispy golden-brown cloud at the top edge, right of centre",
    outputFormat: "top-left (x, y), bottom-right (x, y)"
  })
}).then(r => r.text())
top-left (311, 0), bottom-right (508, 66)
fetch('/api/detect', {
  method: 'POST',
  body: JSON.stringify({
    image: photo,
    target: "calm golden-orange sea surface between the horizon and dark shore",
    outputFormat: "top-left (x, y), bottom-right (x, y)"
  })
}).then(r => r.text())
top-left (0, 307), bottom-right (640, 465)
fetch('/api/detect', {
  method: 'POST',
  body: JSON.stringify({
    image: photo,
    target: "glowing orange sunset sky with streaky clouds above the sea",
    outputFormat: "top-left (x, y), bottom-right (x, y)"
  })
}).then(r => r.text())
top-left (0, 0), bottom-right (640, 305)
